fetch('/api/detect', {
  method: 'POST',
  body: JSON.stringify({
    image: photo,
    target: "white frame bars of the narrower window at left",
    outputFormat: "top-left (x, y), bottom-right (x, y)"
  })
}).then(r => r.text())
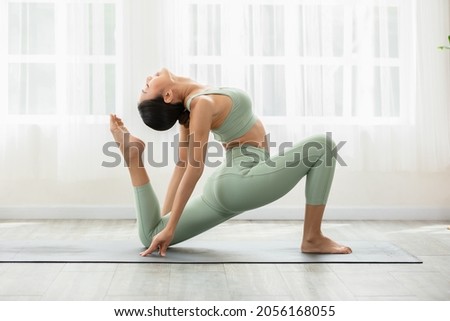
top-left (0, 0), bottom-right (124, 125)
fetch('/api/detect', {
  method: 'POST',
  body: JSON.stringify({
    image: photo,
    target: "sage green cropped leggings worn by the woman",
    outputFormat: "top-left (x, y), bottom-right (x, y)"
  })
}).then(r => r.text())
top-left (134, 135), bottom-right (336, 247)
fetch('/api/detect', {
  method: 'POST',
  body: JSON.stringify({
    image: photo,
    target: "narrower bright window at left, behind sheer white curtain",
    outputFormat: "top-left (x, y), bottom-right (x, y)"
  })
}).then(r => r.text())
top-left (0, 0), bottom-right (122, 119)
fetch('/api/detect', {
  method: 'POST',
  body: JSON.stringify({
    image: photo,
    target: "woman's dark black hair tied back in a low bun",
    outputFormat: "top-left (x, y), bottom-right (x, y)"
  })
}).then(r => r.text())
top-left (138, 97), bottom-right (190, 131)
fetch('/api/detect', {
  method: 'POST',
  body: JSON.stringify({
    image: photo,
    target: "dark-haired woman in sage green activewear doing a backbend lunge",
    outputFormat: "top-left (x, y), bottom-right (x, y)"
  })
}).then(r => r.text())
top-left (110, 69), bottom-right (351, 256)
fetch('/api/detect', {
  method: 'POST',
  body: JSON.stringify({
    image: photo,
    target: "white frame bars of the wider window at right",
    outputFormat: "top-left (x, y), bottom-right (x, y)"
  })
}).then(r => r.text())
top-left (180, 0), bottom-right (416, 126)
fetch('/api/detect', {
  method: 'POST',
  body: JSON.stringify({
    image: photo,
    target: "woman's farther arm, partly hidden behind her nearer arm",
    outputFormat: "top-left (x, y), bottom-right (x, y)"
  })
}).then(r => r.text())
top-left (161, 125), bottom-right (189, 215)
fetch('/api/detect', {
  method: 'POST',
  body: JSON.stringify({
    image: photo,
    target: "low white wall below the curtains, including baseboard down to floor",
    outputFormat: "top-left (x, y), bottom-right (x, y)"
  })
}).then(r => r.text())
top-left (0, 160), bottom-right (450, 220)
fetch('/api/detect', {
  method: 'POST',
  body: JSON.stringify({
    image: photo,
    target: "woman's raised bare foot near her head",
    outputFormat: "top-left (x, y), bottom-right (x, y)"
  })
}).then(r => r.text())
top-left (109, 115), bottom-right (145, 167)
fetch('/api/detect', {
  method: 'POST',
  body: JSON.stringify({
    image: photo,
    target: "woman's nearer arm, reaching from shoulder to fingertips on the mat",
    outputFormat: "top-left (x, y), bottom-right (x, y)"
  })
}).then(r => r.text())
top-left (141, 97), bottom-right (213, 256)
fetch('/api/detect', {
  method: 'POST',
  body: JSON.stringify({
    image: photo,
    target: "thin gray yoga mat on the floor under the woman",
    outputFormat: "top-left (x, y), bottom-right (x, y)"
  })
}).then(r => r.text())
top-left (0, 239), bottom-right (422, 263)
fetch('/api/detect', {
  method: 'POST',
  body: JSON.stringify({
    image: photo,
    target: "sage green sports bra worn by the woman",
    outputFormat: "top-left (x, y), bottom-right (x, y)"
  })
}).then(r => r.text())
top-left (186, 87), bottom-right (257, 143)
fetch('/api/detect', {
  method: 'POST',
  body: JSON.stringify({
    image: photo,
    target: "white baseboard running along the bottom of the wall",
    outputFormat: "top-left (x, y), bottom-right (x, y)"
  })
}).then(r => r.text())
top-left (0, 206), bottom-right (450, 221)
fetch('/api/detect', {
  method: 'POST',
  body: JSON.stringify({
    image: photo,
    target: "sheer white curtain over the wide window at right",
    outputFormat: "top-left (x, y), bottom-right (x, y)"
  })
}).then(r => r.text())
top-left (161, 0), bottom-right (450, 171)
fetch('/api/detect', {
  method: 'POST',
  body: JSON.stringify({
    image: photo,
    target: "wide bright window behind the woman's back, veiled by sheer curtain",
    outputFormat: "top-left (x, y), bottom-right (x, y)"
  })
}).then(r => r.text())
top-left (165, 0), bottom-right (414, 125)
